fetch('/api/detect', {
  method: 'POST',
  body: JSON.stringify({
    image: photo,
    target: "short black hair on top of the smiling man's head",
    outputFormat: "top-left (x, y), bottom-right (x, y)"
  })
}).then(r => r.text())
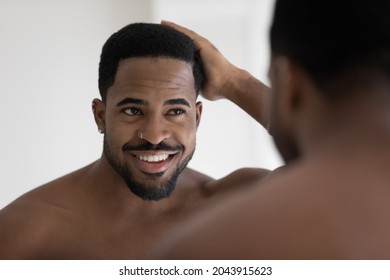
top-left (99, 23), bottom-right (204, 101)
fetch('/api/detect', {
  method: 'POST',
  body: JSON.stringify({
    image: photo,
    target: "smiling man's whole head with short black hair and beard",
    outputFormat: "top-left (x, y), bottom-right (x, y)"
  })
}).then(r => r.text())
top-left (93, 23), bottom-right (203, 200)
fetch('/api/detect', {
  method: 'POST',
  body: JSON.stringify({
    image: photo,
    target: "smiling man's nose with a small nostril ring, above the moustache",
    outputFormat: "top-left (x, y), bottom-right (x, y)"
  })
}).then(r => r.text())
top-left (138, 117), bottom-right (171, 145)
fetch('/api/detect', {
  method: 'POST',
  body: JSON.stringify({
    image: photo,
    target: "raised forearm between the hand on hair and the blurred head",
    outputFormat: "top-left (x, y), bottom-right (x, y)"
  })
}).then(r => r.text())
top-left (221, 68), bottom-right (271, 129)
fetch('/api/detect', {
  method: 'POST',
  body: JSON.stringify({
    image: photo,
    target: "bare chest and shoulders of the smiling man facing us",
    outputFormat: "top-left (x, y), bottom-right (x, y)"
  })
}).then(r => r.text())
top-left (1, 164), bottom-right (210, 259)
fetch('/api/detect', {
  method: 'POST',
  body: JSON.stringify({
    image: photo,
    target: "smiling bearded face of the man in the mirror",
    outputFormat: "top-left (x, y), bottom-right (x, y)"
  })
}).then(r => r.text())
top-left (99, 58), bottom-right (201, 200)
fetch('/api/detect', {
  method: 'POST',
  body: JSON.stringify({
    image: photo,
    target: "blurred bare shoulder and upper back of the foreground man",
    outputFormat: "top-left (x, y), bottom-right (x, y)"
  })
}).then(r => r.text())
top-left (160, 162), bottom-right (390, 259)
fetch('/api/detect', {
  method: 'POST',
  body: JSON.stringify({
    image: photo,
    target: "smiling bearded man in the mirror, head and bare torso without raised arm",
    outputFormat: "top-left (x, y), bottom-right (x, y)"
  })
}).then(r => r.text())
top-left (0, 24), bottom-right (267, 259)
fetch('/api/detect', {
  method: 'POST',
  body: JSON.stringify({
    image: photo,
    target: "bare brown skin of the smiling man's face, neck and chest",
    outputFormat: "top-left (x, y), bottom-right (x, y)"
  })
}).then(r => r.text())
top-left (0, 58), bottom-right (268, 259)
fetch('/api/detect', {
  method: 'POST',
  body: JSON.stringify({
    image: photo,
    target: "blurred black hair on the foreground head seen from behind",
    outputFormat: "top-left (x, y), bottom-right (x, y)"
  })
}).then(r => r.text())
top-left (270, 0), bottom-right (390, 97)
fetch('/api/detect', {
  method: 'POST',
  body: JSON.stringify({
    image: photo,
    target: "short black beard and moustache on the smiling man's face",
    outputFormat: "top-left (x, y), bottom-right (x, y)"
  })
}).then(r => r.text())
top-left (103, 136), bottom-right (195, 200)
